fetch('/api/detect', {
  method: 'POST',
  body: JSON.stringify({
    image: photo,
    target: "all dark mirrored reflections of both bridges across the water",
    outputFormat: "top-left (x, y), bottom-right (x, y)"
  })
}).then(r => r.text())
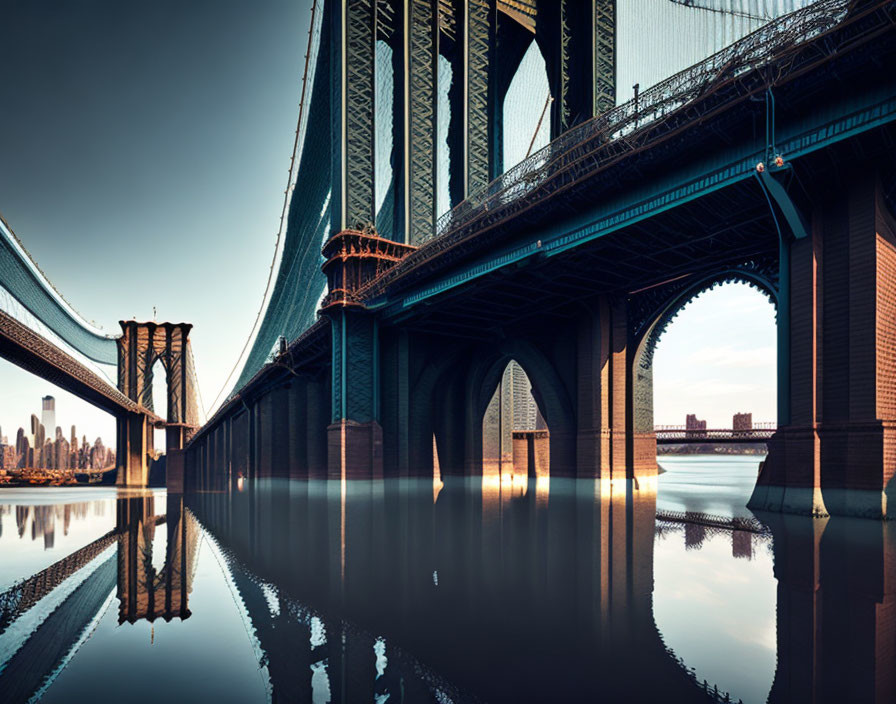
top-left (0, 478), bottom-right (896, 704)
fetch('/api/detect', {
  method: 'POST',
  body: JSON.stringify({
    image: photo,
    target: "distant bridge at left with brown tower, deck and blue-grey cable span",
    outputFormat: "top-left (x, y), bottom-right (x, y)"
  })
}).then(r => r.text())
top-left (0, 218), bottom-right (199, 486)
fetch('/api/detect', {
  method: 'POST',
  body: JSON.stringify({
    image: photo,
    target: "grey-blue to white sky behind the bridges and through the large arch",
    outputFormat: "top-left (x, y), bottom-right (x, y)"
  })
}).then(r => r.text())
top-left (0, 0), bottom-right (775, 439)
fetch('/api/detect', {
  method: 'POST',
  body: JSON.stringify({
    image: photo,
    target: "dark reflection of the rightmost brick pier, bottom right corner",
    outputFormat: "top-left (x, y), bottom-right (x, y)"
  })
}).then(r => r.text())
top-left (760, 512), bottom-right (896, 704)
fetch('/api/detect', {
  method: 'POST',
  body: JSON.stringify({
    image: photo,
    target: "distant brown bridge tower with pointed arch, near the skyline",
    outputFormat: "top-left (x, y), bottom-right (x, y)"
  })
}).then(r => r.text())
top-left (117, 320), bottom-right (199, 486)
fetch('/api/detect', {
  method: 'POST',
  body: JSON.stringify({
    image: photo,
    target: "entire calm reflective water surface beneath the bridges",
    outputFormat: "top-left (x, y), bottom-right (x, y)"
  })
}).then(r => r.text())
top-left (0, 456), bottom-right (896, 704)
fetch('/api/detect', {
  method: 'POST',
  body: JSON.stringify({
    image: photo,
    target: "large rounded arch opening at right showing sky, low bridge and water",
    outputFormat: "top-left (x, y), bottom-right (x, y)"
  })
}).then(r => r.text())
top-left (632, 272), bottom-right (778, 516)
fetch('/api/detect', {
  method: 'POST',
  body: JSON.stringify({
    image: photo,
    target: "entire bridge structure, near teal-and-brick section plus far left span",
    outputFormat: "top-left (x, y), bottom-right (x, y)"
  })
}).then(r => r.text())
top-left (0, 0), bottom-right (896, 516)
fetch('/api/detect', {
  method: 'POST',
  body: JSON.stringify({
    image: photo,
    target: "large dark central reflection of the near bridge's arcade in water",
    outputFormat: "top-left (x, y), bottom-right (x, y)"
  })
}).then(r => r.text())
top-left (188, 479), bottom-right (721, 702)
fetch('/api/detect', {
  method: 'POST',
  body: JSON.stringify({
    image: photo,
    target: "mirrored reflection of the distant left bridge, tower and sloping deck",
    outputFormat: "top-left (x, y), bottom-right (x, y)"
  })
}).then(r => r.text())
top-left (0, 494), bottom-right (198, 702)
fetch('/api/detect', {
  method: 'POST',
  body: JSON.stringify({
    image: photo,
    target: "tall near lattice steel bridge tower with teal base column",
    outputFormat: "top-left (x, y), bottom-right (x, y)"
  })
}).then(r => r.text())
top-left (323, 0), bottom-right (616, 476)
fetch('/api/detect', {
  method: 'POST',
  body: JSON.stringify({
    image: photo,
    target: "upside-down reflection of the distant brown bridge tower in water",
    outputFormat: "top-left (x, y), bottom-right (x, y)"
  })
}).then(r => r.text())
top-left (117, 495), bottom-right (199, 623)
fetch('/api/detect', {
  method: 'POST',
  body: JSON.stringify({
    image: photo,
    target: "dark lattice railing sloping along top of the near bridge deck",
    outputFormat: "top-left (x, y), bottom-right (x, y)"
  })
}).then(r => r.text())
top-left (358, 0), bottom-right (860, 302)
